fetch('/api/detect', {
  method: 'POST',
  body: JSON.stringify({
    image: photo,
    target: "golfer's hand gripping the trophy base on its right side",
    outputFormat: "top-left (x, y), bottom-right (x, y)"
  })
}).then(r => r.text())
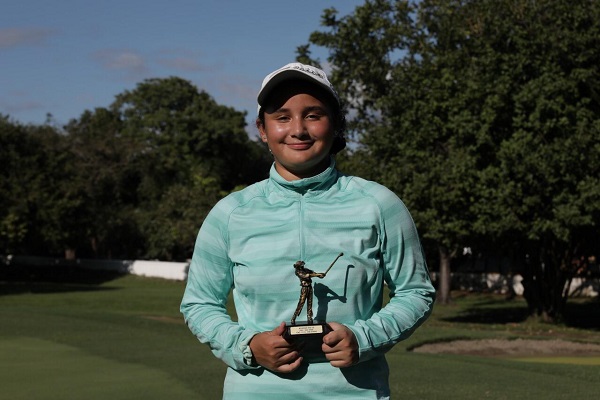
top-left (321, 322), bottom-right (358, 368)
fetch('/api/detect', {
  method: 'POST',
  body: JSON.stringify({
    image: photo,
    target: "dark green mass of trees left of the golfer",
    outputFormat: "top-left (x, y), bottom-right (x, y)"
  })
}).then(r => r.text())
top-left (0, 77), bottom-right (271, 260)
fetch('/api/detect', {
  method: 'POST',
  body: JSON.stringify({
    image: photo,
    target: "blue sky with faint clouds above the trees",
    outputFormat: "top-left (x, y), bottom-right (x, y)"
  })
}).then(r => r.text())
top-left (0, 0), bottom-right (364, 135)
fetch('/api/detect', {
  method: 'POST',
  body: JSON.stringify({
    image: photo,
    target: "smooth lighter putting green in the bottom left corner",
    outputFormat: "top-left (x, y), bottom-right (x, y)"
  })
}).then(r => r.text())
top-left (0, 337), bottom-right (196, 400)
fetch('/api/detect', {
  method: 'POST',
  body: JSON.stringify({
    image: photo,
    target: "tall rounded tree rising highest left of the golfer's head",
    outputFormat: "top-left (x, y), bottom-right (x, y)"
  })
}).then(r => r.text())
top-left (110, 77), bottom-right (265, 193)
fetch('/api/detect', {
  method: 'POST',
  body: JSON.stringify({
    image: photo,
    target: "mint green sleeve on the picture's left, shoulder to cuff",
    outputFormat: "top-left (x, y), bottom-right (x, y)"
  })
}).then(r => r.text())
top-left (180, 205), bottom-right (258, 369)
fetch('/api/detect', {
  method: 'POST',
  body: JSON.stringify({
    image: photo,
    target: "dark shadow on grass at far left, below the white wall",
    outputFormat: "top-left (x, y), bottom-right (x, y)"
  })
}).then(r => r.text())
top-left (0, 265), bottom-right (123, 296)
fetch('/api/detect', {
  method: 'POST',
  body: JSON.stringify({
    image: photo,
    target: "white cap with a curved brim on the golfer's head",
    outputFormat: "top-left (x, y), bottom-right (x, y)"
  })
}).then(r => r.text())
top-left (258, 63), bottom-right (340, 112)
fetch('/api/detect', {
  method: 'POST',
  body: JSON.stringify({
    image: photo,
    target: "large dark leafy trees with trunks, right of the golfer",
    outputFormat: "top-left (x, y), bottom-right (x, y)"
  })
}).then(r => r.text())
top-left (299, 0), bottom-right (600, 320)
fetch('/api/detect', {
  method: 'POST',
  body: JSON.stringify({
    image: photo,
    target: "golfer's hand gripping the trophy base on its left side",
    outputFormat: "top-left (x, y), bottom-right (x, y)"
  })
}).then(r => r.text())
top-left (249, 322), bottom-right (302, 373)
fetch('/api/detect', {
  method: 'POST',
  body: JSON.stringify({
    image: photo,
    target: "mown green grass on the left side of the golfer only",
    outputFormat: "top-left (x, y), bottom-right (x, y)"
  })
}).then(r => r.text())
top-left (0, 276), bottom-right (225, 400)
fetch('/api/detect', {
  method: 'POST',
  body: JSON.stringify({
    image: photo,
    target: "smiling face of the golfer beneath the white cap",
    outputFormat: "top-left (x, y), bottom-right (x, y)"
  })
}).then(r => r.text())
top-left (257, 84), bottom-right (334, 181)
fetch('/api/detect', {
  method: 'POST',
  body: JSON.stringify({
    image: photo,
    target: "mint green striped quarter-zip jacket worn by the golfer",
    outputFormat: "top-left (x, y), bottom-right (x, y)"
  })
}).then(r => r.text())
top-left (181, 159), bottom-right (435, 400)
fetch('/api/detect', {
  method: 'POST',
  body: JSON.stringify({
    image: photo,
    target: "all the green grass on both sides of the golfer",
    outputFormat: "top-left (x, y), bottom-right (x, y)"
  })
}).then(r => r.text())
top-left (0, 276), bottom-right (600, 400)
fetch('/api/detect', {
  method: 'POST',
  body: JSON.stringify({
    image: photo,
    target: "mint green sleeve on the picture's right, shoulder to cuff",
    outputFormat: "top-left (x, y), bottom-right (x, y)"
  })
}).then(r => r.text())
top-left (347, 187), bottom-right (435, 362)
